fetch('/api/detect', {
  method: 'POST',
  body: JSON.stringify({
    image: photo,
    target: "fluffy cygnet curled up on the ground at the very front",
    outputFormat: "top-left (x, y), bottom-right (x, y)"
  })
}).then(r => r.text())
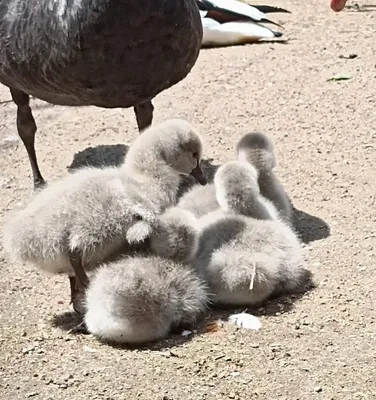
top-left (84, 256), bottom-right (207, 344)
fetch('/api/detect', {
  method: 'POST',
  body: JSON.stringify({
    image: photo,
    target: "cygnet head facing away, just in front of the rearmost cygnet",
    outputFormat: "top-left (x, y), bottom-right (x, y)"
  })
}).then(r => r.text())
top-left (214, 161), bottom-right (260, 215)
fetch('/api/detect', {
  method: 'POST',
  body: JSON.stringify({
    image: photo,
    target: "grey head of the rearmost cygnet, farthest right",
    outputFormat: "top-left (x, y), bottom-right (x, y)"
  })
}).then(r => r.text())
top-left (236, 132), bottom-right (276, 172)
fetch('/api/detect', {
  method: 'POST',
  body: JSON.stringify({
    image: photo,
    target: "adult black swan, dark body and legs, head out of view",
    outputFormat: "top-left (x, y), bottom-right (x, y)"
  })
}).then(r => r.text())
top-left (0, 0), bottom-right (202, 187)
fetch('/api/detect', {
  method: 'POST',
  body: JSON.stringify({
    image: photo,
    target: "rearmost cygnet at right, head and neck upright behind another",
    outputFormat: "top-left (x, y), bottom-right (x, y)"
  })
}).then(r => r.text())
top-left (237, 132), bottom-right (293, 223)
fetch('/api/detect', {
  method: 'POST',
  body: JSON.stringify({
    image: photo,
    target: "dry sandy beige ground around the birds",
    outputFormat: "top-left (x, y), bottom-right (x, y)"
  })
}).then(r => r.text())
top-left (0, 0), bottom-right (376, 400)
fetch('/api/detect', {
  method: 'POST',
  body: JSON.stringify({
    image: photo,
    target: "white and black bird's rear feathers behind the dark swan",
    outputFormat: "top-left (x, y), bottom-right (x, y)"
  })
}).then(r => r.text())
top-left (196, 0), bottom-right (290, 47)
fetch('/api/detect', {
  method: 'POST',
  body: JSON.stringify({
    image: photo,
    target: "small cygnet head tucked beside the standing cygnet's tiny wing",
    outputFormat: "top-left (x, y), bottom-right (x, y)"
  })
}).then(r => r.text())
top-left (150, 207), bottom-right (198, 262)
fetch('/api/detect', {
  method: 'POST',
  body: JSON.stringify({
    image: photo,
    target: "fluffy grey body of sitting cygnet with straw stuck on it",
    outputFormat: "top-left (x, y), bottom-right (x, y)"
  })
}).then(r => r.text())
top-left (192, 211), bottom-right (309, 306)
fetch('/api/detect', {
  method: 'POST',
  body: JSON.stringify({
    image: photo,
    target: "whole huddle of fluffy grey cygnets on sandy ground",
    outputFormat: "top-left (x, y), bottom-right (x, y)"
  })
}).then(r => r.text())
top-left (3, 119), bottom-right (309, 343)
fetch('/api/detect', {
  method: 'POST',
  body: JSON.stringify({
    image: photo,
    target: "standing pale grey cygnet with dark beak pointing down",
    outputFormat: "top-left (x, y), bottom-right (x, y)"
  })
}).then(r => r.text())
top-left (4, 119), bottom-right (205, 312)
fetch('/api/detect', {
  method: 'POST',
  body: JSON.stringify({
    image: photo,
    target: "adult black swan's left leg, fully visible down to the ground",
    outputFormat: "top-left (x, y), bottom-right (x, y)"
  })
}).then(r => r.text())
top-left (10, 88), bottom-right (46, 189)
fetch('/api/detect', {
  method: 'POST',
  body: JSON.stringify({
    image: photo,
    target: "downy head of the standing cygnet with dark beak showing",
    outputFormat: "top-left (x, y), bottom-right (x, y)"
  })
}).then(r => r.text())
top-left (125, 119), bottom-right (206, 185)
